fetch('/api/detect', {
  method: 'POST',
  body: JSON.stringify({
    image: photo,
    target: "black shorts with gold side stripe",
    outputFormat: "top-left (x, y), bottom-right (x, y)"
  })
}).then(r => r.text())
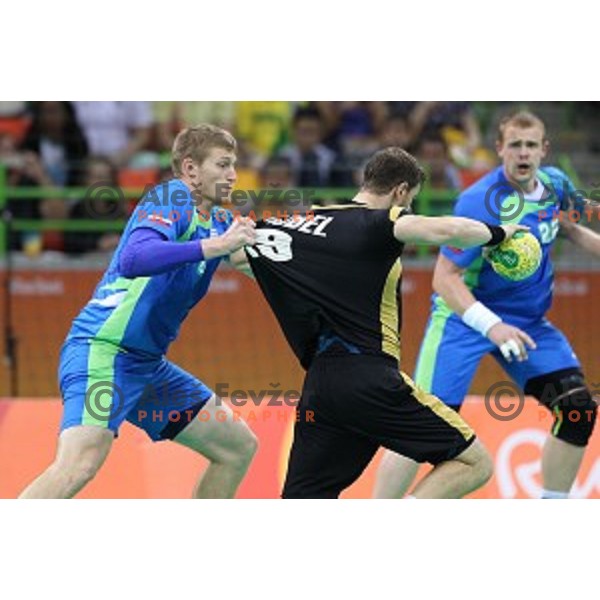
top-left (282, 355), bottom-right (475, 498)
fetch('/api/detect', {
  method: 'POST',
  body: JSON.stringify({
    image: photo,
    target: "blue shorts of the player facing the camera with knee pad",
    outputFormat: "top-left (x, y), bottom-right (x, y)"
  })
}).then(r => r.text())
top-left (415, 311), bottom-right (581, 408)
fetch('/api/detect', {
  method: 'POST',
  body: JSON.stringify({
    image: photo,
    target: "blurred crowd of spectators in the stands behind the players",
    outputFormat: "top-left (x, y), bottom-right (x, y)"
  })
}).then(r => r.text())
top-left (0, 101), bottom-right (600, 255)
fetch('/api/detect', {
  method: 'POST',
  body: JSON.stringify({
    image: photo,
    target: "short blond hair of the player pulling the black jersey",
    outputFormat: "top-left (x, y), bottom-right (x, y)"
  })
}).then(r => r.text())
top-left (171, 123), bottom-right (237, 177)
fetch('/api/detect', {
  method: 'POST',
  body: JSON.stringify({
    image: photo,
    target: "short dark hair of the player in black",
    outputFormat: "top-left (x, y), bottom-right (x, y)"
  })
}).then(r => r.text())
top-left (362, 146), bottom-right (426, 194)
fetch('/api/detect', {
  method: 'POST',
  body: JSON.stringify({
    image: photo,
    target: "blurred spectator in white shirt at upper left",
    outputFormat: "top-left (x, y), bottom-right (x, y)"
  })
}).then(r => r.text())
top-left (73, 102), bottom-right (152, 167)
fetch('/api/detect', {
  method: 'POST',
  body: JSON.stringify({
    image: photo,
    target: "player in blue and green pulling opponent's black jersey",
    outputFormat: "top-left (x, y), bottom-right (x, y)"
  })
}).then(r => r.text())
top-left (21, 125), bottom-right (256, 498)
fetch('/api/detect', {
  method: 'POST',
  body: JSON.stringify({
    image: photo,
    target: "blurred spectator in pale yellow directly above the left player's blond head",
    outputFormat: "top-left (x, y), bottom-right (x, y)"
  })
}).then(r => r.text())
top-left (152, 101), bottom-right (235, 153)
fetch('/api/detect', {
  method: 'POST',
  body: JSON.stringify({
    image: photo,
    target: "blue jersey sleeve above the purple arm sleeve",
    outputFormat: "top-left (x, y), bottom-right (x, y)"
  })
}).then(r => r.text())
top-left (131, 185), bottom-right (194, 242)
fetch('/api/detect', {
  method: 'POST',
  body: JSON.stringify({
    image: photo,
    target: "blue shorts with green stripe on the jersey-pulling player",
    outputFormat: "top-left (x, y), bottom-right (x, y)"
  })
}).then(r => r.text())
top-left (59, 340), bottom-right (213, 441)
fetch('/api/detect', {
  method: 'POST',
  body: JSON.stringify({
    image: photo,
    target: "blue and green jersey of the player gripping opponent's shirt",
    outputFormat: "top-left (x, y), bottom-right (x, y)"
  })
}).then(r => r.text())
top-left (67, 179), bottom-right (232, 357)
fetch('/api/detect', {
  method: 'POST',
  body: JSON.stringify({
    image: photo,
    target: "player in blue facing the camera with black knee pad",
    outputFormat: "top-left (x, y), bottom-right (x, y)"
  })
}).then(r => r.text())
top-left (375, 112), bottom-right (600, 498)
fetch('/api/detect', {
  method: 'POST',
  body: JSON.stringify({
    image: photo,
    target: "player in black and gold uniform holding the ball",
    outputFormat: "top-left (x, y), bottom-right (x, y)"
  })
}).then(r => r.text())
top-left (237, 148), bottom-right (525, 498)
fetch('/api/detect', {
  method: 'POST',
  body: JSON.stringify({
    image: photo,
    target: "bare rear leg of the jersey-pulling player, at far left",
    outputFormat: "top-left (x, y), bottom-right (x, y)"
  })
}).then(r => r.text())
top-left (19, 425), bottom-right (114, 499)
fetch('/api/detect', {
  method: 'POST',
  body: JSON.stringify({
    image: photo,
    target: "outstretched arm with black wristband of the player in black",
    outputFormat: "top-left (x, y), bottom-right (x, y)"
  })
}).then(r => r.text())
top-left (394, 215), bottom-right (528, 248)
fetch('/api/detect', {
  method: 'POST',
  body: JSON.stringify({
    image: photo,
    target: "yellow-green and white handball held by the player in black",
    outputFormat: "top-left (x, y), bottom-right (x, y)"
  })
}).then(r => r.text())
top-left (486, 231), bottom-right (542, 281)
